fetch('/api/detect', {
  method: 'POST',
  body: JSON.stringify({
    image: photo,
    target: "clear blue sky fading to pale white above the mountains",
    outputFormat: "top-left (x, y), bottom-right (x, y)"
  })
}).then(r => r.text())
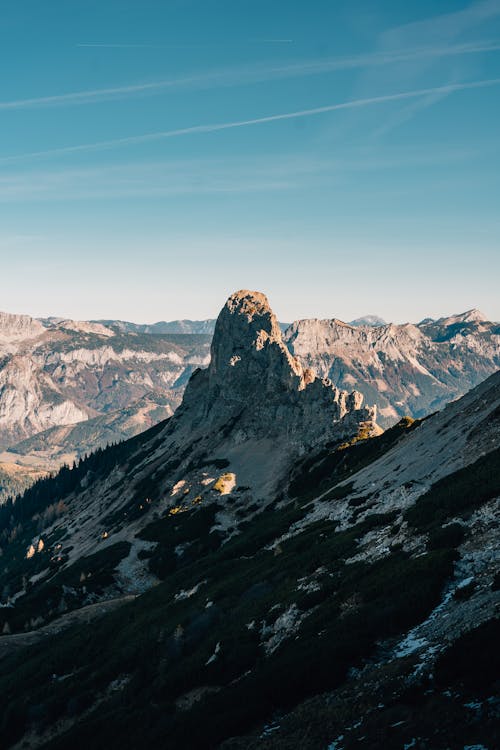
top-left (0, 0), bottom-right (500, 322)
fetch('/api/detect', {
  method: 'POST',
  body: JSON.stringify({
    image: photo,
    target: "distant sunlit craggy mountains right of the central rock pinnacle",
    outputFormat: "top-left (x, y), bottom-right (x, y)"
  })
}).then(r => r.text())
top-left (285, 310), bottom-right (500, 427)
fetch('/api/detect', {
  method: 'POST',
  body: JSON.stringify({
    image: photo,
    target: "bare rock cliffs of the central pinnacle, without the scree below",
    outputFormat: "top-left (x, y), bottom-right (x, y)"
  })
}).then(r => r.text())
top-left (175, 290), bottom-right (376, 451)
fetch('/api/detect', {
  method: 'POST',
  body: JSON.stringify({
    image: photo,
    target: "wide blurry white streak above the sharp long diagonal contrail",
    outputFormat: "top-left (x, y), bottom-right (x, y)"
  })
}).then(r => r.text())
top-left (0, 41), bottom-right (500, 111)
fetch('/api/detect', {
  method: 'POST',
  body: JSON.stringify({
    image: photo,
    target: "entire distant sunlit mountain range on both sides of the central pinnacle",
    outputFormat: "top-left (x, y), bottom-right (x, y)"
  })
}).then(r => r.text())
top-left (0, 302), bottom-right (500, 498)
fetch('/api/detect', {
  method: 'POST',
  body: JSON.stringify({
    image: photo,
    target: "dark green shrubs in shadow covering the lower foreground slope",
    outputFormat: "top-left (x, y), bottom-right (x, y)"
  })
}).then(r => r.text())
top-left (0, 494), bottom-right (454, 750)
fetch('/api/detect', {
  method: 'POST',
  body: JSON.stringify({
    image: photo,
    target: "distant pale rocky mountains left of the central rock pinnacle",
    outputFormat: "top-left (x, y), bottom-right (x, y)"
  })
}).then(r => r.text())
top-left (0, 313), bottom-right (210, 464)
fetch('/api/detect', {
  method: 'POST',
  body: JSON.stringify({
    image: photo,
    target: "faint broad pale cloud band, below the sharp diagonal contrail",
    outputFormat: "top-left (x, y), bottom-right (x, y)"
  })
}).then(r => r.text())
top-left (0, 145), bottom-right (484, 204)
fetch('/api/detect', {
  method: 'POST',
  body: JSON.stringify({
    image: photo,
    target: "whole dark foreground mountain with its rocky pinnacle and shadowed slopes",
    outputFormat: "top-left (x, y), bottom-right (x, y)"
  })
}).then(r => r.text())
top-left (0, 291), bottom-right (500, 750)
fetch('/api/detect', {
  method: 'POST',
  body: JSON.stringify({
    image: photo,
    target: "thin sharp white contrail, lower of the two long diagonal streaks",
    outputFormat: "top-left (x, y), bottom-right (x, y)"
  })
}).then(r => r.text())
top-left (0, 78), bottom-right (500, 164)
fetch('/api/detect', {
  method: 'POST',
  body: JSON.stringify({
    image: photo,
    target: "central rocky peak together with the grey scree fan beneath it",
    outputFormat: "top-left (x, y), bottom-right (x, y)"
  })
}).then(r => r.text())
top-left (146, 290), bottom-right (380, 506)
